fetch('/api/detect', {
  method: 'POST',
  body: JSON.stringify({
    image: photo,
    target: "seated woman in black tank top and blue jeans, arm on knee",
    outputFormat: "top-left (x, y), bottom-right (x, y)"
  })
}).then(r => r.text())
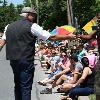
top-left (61, 57), bottom-right (96, 100)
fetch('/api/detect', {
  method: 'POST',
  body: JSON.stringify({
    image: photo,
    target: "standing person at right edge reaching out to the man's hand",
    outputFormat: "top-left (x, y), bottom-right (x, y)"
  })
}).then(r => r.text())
top-left (78, 11), bottom-right (100, 100)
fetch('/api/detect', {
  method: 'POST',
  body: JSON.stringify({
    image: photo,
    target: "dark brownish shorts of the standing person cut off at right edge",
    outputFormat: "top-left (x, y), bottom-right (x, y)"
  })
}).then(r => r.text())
top-left (95, 60), bottom-right (100, 95)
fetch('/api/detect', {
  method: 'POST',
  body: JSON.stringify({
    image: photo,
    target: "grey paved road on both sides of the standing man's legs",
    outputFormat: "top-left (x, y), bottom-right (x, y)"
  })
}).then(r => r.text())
top-left (0, 48), bottom-right (60, 100)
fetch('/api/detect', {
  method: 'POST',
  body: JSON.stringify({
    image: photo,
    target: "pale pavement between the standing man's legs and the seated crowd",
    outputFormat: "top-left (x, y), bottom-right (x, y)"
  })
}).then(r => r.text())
top-left (32, 57), bottom-right (61, 100)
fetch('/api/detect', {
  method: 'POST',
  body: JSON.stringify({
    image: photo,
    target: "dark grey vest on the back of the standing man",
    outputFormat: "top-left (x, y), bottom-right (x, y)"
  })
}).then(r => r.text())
top-left (6, 18), bottom-right (36, 60)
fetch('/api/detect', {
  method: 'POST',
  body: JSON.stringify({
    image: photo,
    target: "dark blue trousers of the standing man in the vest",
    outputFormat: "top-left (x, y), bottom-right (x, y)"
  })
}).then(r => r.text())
top-left (10, 60), bottom-right (35, 100)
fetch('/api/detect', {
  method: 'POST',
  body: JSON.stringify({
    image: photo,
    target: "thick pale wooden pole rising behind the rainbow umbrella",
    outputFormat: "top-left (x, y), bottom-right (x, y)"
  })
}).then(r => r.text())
top-left (67, 0), bottom-right (74, 26)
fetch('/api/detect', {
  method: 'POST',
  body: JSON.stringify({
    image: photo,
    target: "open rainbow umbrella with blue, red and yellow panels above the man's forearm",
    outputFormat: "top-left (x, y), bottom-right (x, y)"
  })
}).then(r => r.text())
top-left (51, 25), bottom-right (76, 35)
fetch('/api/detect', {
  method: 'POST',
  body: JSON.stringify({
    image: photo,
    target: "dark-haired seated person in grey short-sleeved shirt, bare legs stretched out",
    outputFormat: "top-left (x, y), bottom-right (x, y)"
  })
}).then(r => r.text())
top-left (40, 56), bottom-right (83, 94)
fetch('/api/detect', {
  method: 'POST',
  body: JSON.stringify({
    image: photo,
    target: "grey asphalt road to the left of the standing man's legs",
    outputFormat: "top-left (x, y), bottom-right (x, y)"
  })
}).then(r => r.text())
top-left (0, 48), bottom-right (14, 100)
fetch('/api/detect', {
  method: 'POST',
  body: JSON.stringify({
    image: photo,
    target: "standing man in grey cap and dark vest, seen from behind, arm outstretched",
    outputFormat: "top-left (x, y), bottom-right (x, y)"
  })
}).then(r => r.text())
top-left (0, 7), bottom-right (75, 100)
